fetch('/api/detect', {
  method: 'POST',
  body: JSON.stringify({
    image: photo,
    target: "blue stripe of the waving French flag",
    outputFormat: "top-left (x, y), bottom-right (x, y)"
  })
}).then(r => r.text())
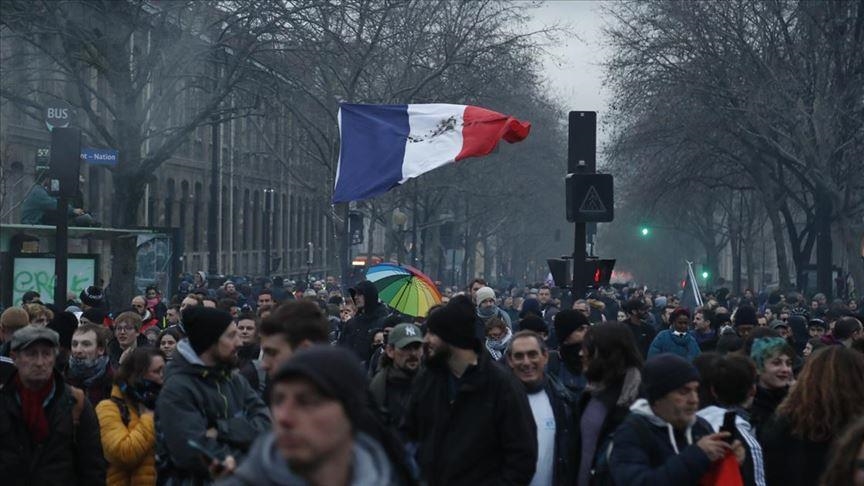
top-left (333, 103), bottom-right (411, 203)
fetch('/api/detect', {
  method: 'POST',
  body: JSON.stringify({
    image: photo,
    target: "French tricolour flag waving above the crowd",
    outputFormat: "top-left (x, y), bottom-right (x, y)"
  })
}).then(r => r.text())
top-left (333, 103), bottom-right (531, 203)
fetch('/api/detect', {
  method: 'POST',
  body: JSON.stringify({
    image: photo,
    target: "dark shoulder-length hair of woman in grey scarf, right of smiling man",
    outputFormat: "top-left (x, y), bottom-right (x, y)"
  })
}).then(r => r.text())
top-left (582, 322), bottom-right (642, 384)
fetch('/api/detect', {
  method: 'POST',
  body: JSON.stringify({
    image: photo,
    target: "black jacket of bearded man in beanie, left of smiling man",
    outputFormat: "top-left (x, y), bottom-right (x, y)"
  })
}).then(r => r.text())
top-left (402, 352), bottom-right (537, 486)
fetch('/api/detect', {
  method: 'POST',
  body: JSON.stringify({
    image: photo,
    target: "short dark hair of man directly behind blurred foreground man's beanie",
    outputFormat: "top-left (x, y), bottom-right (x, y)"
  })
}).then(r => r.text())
top-left (258, 300), bottom-right (330, 348)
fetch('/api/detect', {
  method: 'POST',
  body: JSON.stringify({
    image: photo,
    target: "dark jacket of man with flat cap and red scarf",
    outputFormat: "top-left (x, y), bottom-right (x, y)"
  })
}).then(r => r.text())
top-left (0, 373), bottom-right (106, 486)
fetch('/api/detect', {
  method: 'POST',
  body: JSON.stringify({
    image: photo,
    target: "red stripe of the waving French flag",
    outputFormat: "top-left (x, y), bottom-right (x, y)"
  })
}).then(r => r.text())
top-left (456, 106), bottom-right (531, 160)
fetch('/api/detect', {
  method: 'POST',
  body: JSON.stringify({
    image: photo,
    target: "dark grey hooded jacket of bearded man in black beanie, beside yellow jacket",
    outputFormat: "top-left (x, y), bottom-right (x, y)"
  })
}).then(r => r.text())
top-left (156, 339), bottom-right (270, 484)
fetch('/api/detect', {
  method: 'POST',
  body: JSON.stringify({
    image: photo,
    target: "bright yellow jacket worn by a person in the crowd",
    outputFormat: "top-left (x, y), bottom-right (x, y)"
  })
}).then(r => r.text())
top-left (96, 385), bottom-right (156, 486)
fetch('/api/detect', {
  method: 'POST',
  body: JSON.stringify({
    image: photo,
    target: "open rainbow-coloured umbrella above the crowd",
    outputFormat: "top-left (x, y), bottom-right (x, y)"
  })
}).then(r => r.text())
top-left (366, 263), bottom-right (441, 317)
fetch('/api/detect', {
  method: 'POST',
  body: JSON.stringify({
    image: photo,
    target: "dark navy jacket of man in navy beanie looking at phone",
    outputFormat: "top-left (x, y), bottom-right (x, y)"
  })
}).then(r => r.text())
top-left (609, 399), bottom-right (712, 486)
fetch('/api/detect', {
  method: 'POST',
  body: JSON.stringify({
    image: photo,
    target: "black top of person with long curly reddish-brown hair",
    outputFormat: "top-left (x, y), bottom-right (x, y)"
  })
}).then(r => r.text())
top-left (759, 415), bottom-right (831, 486)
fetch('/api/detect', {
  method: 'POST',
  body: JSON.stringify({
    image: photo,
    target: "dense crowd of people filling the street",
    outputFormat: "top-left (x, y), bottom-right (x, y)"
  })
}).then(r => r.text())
top-left (0, 272), bottom-right (864, 486)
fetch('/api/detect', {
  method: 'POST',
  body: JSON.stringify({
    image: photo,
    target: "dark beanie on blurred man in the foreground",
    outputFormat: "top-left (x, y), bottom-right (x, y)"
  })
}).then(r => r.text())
top-left (272, 345), bottom-right (368, 426)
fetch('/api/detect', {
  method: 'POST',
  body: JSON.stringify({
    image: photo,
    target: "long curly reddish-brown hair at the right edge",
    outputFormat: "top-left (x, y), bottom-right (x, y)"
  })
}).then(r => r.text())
top-left (777, 346), bottom-right (864, 442)
